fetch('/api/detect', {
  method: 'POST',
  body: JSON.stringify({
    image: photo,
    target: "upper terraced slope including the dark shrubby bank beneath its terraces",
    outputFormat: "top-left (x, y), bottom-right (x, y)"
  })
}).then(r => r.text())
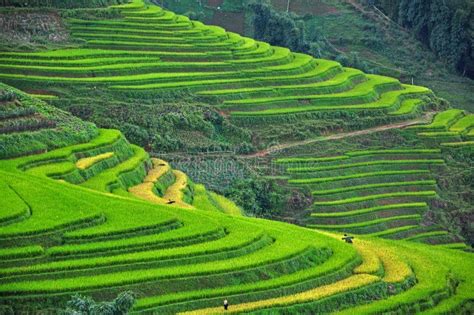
top-left (0, 0), bottom-right (444, 152)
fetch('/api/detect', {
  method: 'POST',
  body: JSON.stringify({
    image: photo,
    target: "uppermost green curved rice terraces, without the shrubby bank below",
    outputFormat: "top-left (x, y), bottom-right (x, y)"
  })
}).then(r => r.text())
top-left (0, 0), bottom-right (432, 124)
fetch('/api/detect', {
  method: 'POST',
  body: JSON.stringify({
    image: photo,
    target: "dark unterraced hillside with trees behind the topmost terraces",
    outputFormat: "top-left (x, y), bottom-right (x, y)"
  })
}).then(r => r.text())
top-left (159, 0), bottom-right (474, 111)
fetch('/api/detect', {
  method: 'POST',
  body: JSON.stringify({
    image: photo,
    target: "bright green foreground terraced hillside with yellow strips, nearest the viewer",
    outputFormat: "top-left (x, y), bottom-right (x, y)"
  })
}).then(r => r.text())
top-left (0, 87), bottom-right (474, 314)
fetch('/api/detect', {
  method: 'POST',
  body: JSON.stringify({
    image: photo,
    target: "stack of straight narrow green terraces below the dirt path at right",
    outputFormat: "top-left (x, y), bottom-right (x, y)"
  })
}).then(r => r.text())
top-left (276, 149), bottom-right (462, 243)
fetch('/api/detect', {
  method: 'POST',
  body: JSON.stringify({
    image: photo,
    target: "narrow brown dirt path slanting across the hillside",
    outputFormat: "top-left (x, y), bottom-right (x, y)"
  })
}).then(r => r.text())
top-left (243, 112), bottom-right (436, 158)
